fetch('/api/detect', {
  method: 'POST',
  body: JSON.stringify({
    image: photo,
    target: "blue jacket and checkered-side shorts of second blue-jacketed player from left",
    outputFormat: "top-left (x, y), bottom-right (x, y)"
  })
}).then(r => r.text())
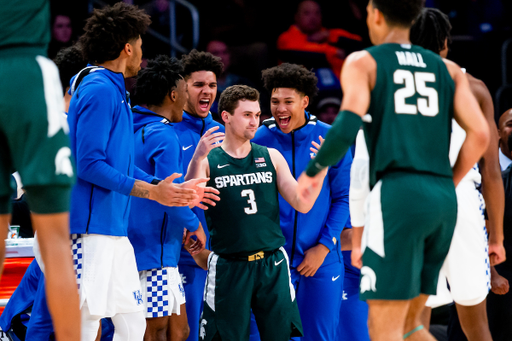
top-left (128, 106), bottom-right (199, 318)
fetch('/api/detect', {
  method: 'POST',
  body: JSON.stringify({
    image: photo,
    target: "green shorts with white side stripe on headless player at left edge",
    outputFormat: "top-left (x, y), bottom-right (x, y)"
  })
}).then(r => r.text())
top-left (0, 47), bottom-right (74, 214)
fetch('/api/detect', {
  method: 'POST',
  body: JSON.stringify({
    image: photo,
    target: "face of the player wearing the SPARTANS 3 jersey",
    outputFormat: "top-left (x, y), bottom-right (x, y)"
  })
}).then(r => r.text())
top-left (222, 100), bottom-right (261, 141)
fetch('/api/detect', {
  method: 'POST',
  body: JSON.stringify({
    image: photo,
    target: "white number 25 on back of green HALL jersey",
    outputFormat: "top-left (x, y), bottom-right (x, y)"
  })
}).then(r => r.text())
top-left (393, 70), bottom-right (439, 117)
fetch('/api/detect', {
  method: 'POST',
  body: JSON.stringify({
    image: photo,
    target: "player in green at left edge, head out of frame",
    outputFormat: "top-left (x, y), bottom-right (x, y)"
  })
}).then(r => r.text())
top-left (0, 0), bottom-right (80, 340)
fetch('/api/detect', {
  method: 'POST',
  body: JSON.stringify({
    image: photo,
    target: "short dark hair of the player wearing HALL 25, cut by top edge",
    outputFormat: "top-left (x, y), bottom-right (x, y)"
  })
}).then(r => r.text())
top-left (371, 0), bottom-right (425, 27)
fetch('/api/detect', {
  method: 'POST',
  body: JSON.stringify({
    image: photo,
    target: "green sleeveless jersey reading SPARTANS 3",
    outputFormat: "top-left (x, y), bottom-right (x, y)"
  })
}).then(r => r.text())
top-left (205, 143), bottom-right (285, 256)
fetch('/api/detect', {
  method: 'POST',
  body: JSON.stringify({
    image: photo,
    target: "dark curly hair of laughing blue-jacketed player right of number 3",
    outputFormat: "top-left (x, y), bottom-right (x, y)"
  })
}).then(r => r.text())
top-left (261, 63), bottom-right (318, 99)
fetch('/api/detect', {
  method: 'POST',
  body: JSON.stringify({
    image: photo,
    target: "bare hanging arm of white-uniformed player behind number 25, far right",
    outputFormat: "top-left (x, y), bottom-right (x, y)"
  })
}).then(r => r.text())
top-left (467, 74), bottom-right (505, 265)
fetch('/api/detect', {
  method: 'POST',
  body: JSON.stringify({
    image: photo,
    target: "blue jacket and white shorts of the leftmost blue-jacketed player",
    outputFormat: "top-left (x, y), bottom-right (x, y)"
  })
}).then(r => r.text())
top-left (68, 68), bottom-right (153, 318)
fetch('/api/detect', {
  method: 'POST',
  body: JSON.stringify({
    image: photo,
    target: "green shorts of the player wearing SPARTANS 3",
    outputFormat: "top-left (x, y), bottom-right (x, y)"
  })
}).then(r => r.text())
top-left (199, 247), bottom-right (302, 341)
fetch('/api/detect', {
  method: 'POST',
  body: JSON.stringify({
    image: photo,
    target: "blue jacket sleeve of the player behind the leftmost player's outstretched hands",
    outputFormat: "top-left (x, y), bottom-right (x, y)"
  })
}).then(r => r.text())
top-left (146, 126), bottom-right (199, 232)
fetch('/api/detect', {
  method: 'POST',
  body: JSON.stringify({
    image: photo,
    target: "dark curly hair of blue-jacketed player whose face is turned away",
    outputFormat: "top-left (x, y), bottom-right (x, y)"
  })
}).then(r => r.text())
top-left (134, 55), bottom-right (183, 105)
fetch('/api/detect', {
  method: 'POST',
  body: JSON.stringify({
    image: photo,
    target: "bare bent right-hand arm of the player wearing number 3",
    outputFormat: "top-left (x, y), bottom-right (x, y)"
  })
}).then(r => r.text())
top-left (268, 148), bottom-right (327, 213)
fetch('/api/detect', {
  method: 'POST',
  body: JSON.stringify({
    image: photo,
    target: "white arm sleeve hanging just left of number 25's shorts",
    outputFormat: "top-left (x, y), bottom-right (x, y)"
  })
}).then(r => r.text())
top-left (350, 129), bottom-right (370, 227)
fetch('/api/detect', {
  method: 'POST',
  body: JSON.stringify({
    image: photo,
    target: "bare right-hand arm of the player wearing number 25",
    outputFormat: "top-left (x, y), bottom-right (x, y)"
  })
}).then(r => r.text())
top-left (444, 59), bottom-right (490, 186)
